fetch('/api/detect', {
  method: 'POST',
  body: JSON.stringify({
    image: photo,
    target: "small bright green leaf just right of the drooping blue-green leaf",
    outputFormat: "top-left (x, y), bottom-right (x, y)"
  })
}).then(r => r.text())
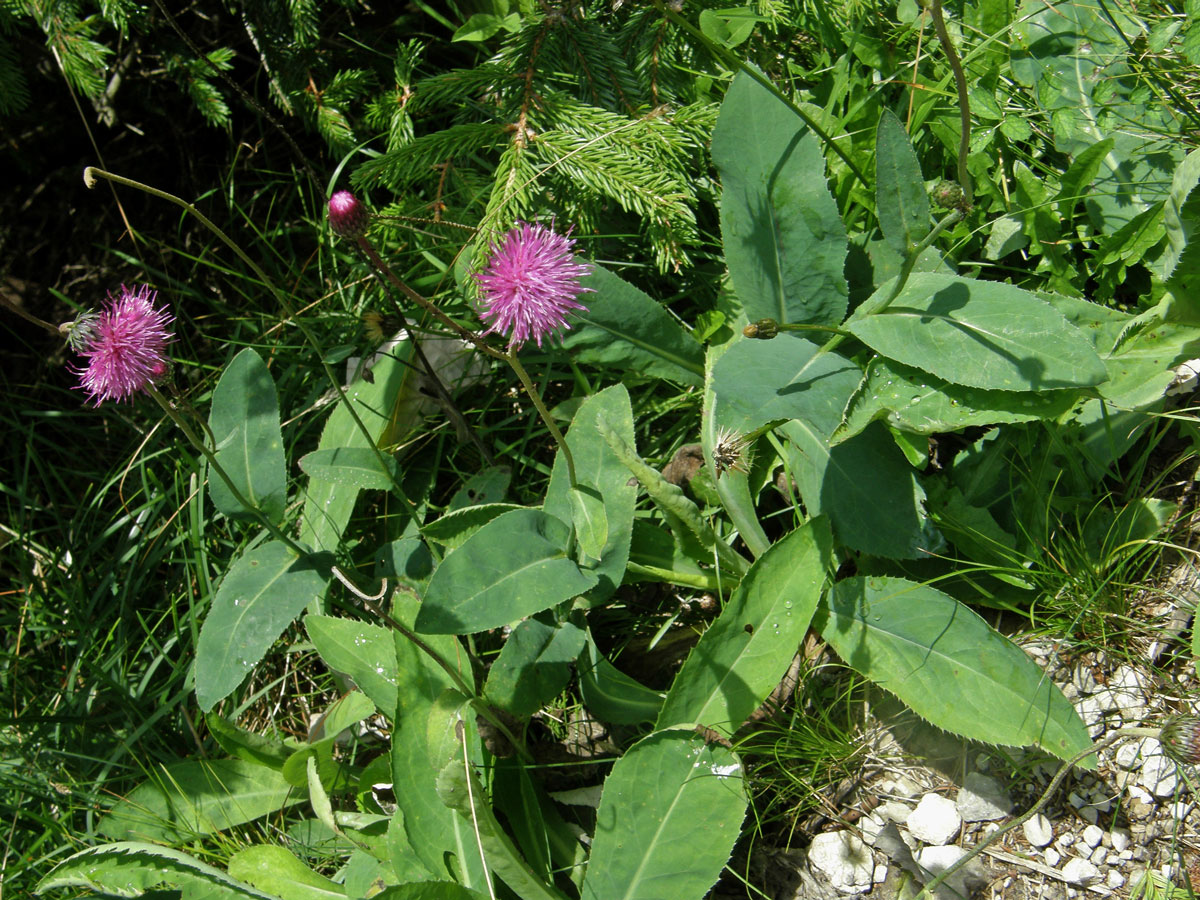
top-left (304, 616), bottom-right (396, 716)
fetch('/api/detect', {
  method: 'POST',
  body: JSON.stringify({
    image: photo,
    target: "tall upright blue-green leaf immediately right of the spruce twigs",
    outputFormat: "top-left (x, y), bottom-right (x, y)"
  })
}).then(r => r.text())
top-left (712, 72), bottom-right (847, 324)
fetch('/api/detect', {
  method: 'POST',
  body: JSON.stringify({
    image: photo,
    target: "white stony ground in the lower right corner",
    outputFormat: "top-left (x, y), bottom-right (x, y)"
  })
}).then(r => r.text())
top-left (751, 563), bottom-right (1200, 900)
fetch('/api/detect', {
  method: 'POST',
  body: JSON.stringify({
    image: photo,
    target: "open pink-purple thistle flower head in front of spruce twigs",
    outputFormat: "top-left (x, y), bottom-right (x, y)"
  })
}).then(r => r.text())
top-left (475, 222), bottom-right (592, 349)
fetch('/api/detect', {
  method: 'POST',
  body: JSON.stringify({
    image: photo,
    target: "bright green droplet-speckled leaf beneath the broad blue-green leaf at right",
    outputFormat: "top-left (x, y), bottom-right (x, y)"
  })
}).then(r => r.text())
top-left (832, 356), bottom-right (1079, 444)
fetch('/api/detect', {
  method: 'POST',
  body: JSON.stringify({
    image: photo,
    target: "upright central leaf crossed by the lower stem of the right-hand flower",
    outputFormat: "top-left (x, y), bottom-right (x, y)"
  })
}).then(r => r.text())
top-left (542, 386), bottom-right (638, 601)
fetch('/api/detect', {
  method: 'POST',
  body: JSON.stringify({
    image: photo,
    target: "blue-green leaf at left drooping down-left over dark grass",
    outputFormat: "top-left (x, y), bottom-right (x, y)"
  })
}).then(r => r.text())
top-left (196, 541), bottom-right (329, 713)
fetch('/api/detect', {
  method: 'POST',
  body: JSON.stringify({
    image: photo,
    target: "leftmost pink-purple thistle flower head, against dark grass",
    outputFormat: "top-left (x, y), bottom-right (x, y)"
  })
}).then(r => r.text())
top-left (78, 284), bottom-right (174, 406)
